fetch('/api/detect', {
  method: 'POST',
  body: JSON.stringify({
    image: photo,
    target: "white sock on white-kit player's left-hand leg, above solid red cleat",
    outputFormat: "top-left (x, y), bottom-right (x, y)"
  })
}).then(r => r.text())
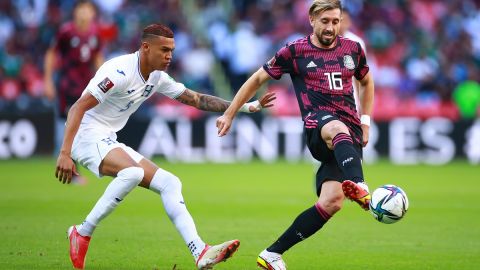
top-left (77, 167), bottom-right (144, 236)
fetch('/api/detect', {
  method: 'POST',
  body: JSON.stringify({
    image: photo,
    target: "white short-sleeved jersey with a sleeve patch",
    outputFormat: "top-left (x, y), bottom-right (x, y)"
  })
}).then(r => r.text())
top-left (80, 51), bottom-right (186, 132)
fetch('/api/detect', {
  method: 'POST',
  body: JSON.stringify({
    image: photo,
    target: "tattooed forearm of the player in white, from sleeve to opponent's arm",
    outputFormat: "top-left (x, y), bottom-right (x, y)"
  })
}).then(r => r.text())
top-left (177, 89), bottom-right (230, 112)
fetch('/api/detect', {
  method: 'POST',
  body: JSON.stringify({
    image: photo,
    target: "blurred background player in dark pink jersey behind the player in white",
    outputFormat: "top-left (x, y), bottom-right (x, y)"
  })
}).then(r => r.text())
top-left (44, 0), bottom-right (104, 154)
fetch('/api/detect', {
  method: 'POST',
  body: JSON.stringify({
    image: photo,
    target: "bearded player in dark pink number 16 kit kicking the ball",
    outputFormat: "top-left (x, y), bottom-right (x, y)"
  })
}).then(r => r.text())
top-left (217, 0), bottom-right (374, 270)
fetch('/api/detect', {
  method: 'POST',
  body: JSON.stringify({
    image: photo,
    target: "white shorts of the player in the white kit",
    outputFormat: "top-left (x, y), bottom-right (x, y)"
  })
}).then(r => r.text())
top-left (72, 129), bottom-right (144, 178)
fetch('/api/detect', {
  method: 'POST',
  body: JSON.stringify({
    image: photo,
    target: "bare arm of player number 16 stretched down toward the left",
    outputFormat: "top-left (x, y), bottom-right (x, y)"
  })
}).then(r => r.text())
top-left (217, 67), bottom-right (275, 137)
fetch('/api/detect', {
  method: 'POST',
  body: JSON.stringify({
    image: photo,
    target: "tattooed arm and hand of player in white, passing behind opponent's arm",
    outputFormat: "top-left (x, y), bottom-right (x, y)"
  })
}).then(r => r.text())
top-left (177, 88), bottom-right (276, 112)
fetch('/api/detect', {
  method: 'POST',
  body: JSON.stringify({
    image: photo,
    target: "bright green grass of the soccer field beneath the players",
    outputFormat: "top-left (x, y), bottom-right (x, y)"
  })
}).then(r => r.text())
top-left (0, 158), bottom-right (480, 270)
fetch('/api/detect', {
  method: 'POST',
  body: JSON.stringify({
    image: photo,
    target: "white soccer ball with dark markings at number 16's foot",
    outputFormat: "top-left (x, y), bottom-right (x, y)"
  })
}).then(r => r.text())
top-left (369, 185), bottom-right (408, 224)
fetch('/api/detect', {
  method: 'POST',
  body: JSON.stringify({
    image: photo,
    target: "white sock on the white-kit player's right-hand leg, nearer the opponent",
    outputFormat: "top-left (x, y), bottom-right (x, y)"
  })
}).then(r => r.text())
top-left (150, 168), bottom-right (205, 261)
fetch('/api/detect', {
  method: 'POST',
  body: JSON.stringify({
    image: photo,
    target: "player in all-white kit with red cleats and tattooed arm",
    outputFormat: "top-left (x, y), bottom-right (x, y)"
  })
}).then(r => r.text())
top-left (55, 24), bottom-right (275, 269)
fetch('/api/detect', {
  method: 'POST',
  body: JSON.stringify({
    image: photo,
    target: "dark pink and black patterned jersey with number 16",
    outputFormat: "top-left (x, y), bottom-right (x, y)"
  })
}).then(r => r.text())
top-left (263, 36), bottom-right (369, 142)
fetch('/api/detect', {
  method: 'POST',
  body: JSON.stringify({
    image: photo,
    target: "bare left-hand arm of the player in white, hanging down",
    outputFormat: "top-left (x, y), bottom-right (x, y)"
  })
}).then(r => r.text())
top-left (55, 93), bottom-right (98, 184)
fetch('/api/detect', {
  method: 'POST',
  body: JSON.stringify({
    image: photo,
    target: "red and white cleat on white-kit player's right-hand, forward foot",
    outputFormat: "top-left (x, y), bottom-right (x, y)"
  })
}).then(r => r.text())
top-left (196, 240), bottom-right (240, 270)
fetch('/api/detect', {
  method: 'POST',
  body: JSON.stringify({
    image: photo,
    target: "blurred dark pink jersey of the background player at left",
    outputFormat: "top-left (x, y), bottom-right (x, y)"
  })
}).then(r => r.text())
top-left (54, 23), bottom-right (101, 116)
